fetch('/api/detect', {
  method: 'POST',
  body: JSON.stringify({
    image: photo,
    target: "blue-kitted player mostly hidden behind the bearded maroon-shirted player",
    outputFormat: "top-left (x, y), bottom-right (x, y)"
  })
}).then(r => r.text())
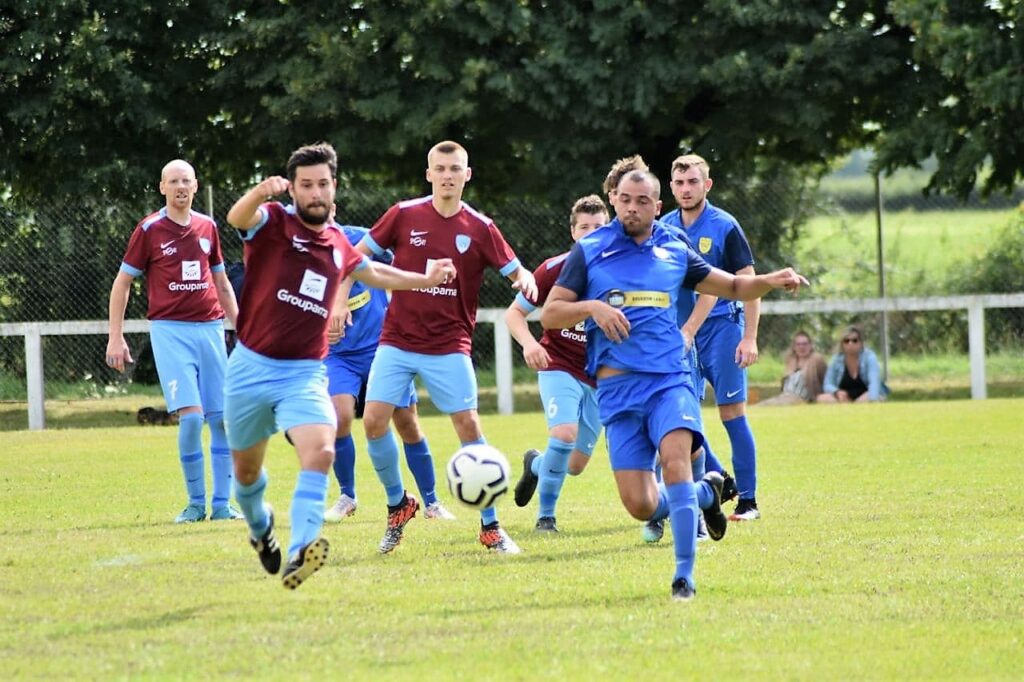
top-left (324, 225), bottom-right (455, 522)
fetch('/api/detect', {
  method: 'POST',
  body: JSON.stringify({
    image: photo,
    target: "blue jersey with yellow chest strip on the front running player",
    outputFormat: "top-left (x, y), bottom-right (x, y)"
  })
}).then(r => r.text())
top-left (556, 218), bottom-right (711, 376)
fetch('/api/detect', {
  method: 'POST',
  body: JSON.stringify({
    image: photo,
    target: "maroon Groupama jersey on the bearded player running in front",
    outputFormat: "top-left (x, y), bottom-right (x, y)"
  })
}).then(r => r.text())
top-left (239, 202), bottom-right (369, 359)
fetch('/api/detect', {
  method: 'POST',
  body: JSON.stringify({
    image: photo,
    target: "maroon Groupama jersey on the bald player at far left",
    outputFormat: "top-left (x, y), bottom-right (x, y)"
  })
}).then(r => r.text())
top-left (121, 208), bottom-right (224, 322)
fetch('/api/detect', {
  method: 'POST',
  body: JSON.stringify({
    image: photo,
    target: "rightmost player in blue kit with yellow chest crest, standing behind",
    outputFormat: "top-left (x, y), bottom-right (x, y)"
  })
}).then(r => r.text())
top-left (662, 154), bottom-right (761, 521)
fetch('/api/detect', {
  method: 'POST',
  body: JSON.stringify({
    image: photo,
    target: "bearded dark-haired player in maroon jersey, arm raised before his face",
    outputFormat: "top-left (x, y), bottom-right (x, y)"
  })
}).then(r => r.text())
top-left (224, 143), bottom-right (456, 590)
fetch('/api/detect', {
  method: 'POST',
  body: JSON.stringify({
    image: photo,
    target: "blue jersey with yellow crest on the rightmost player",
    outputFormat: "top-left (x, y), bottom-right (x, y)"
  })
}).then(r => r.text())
top-left (662, 200), bottom-right (754, 325)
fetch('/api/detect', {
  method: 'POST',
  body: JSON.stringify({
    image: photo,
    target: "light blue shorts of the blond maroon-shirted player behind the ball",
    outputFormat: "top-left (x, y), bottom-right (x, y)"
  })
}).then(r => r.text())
top-left (367, 345), bottom-right (476, 415)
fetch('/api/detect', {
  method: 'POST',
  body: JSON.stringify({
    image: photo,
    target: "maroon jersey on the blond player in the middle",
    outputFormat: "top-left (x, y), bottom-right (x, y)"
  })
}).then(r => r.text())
top-left (365, 197), bottom-right (519, 355)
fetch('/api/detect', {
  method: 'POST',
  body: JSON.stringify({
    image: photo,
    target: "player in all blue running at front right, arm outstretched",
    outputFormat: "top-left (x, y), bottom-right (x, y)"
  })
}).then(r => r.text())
top-left (541, 171), bottom-right (806, 600)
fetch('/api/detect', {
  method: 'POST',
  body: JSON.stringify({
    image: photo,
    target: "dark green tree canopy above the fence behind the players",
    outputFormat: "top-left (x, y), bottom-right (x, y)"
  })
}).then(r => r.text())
top-left (0, 0), bottom-right (1024, 201)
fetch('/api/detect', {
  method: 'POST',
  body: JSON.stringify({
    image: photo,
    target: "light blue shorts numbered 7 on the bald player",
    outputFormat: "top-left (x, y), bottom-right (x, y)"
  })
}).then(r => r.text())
top-left (150, 319), bottom-right (227, 414)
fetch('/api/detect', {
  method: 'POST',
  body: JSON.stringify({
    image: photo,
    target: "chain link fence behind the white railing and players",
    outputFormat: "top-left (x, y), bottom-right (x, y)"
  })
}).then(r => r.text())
top-left (0, 178), bottom-right (1024, 427)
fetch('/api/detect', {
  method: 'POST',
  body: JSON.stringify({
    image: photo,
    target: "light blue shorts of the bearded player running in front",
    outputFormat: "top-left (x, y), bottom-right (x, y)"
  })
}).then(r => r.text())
top-left (224, 343), bottom-right (338, 450)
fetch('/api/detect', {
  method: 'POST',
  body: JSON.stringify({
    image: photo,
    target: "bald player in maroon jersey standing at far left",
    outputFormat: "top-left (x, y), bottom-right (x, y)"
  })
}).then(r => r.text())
top-left (106, 159), bottom-right (242, 523)
